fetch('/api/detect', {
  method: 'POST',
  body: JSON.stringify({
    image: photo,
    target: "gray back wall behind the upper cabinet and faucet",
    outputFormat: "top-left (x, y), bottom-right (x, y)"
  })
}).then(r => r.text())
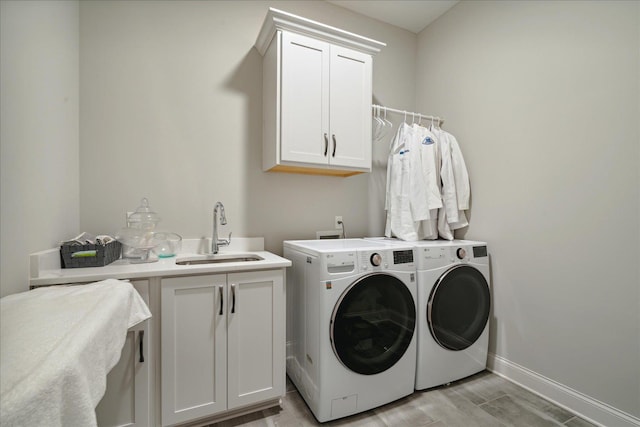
top-left (80, 1), bottom-right (417, 253)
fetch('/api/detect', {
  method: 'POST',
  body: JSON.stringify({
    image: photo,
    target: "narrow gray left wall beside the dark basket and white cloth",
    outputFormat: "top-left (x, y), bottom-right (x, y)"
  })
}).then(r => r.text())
top-left (0, 1), bottom-right (80, 296)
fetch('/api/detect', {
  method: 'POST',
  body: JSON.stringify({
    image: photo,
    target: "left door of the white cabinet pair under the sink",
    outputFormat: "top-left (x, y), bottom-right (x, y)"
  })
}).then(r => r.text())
top-left (161, 274), bottom-right (228, 425)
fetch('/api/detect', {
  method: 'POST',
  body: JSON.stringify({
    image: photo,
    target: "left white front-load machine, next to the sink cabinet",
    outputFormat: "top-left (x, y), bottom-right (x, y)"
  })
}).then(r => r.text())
top-left (284, 239), bottom-right (417, 422)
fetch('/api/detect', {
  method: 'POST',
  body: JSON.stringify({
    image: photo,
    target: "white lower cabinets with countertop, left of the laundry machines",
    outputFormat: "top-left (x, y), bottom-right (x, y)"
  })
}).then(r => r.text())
top-left (30, 241), bottom-right (291, 427)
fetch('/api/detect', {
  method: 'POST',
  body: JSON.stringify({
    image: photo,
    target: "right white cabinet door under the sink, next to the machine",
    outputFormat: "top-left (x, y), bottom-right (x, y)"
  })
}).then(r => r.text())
top-left (227, 270), bottom-right (285, 409)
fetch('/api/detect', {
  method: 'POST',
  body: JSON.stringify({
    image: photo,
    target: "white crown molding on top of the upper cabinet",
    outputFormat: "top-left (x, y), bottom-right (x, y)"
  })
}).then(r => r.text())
top-left (255, 7), bottom-right (386, 56)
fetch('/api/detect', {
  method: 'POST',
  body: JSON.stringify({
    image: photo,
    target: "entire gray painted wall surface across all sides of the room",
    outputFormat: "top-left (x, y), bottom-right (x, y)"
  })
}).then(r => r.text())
top-left (0, 1), bottom-right (640, 422)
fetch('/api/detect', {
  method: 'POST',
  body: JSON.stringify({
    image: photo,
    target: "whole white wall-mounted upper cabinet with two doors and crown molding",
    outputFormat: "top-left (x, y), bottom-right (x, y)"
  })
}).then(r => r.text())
top-left (256, 9), bottom-right (384, 176)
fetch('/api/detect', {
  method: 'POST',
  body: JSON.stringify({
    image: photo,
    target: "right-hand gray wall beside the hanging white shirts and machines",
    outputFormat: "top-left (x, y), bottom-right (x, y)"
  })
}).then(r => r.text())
top-left (416, 1), bottom-right (640, 422)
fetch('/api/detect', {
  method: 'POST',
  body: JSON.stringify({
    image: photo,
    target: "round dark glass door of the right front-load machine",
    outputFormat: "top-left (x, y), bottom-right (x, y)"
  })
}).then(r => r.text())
top-left (427, 265), bottom-right (491, 351)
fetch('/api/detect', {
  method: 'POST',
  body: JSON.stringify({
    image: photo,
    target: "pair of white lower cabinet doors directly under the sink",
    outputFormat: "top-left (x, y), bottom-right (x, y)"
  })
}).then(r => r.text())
top-left (160, 270), bottom-right (285, 426)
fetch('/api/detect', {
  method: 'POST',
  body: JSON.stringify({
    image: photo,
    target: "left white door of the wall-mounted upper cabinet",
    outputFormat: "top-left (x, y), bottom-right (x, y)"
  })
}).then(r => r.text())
top-left (280, 32), bottom-right (330, 165)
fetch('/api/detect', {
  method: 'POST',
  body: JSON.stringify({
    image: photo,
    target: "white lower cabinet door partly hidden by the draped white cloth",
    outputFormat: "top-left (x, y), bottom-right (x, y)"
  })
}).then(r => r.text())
top-left (96, 280), bottom-right (152, 427)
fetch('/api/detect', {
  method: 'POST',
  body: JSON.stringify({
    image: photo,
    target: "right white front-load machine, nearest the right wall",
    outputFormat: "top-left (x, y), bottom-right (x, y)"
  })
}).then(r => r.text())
top-left (368, 238), bottom-right (491, 390)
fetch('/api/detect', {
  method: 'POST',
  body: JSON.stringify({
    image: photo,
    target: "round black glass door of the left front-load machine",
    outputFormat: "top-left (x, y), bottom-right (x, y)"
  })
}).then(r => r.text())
top-left (329, 273), bottom-right (416, 375)
